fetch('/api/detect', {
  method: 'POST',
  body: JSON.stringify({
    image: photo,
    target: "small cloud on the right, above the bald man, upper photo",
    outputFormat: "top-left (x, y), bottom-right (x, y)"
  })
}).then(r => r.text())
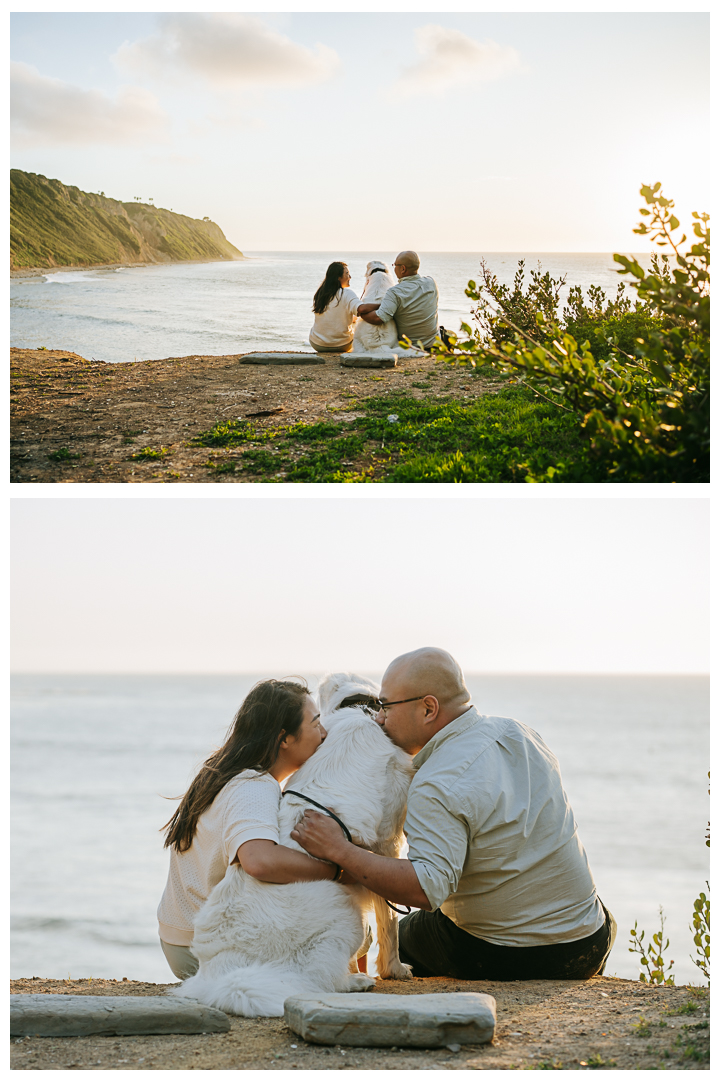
top-left (395, 24), bottom-right (520, 95)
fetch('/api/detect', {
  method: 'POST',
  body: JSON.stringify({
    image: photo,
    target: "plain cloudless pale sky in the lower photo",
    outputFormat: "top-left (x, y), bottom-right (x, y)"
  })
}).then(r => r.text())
top-left (11, 498), bottom-right (709, 677)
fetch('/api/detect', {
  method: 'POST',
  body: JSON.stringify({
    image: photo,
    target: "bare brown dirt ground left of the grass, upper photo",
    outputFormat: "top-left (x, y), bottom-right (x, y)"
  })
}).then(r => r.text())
top-left (10, 349), bottom-right (492, 484)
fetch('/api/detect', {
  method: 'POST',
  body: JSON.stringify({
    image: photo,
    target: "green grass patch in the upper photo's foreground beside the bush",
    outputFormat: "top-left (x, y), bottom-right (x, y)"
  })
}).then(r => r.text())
top-left (185, 387), bottom-right (607, 484)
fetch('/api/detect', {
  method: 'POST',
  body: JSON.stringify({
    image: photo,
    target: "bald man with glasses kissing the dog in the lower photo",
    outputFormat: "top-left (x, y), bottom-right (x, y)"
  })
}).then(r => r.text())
top-left (293, 648), bottom-right (616, 981)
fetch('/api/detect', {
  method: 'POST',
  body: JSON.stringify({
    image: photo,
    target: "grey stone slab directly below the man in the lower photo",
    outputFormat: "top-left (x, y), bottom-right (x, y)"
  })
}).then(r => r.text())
top-left (285, 993), bottom-right (497, 1047)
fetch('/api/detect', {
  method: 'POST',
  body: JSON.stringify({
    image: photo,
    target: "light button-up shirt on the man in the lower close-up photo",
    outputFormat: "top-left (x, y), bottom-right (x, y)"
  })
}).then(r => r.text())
top-left (405, 706), bottom-right (604, 946)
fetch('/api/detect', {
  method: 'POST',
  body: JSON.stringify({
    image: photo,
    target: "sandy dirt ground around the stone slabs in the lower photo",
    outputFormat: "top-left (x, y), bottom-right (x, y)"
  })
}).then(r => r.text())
top-left (11, 977), bottom-right (709, 1070)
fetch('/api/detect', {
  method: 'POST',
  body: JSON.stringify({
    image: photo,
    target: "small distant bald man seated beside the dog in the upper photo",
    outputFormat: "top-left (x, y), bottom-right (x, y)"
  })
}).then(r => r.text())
top-left (357, 252), bottom-right (439, 348)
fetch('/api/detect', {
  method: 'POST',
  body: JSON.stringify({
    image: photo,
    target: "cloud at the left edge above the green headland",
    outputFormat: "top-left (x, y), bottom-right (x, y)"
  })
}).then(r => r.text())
top-left (11, 63), bottom-right (168, 146)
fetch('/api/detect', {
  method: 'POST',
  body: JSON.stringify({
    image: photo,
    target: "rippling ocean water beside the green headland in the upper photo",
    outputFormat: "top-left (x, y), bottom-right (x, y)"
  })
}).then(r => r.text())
top-left (11, 252), bottom-right (650, 363)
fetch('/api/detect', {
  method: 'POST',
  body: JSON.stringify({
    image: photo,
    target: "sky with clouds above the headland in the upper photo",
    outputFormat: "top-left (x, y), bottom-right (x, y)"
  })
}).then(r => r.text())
top-left (11, 11), bottom-right (709, 253)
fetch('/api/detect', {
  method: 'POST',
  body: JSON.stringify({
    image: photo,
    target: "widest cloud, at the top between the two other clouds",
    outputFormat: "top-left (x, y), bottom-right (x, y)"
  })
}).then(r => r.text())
top-left (112, 13), bottom-right (340, 90)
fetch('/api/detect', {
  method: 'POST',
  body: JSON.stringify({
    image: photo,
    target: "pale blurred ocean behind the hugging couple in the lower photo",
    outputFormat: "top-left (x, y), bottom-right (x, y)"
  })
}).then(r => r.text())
top-left (11, 673), bottom-right (709, 985)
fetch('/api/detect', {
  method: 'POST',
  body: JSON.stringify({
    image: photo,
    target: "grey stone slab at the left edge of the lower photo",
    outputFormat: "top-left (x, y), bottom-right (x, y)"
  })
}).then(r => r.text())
top-left (10, 994), bottom-right (230, 1038)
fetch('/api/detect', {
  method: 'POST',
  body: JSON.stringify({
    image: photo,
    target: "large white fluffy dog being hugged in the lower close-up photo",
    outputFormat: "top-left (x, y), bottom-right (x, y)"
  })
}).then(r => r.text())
top-left (171, 674), bottom-right (412, 1016)
